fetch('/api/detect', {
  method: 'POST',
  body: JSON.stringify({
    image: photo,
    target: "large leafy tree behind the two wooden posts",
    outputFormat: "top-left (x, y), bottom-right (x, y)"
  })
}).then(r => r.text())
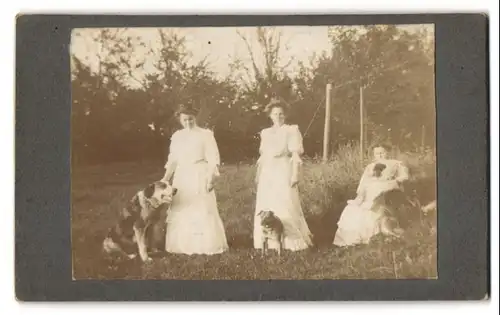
top-left (297, 25), bottom-right (434, 153)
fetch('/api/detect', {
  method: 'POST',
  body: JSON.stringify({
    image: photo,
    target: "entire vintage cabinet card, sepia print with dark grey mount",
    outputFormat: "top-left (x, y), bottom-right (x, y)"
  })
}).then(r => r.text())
top-left (16, 14), bottom-right (489, 301)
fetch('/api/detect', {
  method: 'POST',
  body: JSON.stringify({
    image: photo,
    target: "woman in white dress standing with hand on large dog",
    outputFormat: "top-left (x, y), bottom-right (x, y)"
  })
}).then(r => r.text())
top-left (163, 105), bottom-right (228, 255)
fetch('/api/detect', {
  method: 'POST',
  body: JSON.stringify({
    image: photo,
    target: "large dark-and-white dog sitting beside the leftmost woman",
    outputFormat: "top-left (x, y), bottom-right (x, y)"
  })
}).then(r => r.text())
top-left (102, 181), bottom-right (177, 261)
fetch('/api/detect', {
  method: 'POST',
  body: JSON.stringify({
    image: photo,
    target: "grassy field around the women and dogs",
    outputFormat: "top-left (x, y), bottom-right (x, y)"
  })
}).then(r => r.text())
top-left (72, 147), bottom-right (437, 280)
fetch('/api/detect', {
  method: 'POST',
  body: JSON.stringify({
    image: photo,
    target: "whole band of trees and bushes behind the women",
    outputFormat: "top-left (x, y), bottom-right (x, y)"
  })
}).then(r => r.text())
top-left (72, 26), bottom-right (435, 167)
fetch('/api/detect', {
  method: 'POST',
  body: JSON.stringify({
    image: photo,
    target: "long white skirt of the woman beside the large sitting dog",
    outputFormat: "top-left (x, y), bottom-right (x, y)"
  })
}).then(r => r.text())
top-left (165, 163), bottom-right (228, 255)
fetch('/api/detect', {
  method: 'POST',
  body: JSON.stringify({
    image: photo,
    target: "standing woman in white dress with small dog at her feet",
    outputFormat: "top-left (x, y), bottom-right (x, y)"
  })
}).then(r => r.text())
top-left (253, 101), bottom-right (312, 251)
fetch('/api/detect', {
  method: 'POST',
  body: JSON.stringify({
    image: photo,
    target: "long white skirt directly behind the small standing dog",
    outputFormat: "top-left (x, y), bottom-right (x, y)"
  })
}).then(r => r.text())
top-left (253, 158), bottom-right (312, 251)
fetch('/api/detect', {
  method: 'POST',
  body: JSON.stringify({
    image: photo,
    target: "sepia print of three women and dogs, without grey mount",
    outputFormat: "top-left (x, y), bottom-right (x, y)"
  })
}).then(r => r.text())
top-left (69, 24), bottom-right (439, 281)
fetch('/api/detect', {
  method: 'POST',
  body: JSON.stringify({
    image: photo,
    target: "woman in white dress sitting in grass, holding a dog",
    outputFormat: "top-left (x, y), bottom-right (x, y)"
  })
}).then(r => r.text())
top-left (333, 145), bottom-right (409, 247)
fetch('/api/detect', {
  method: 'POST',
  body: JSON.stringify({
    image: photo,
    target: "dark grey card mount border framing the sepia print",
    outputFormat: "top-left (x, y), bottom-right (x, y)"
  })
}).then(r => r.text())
top-left (15, 13), bottom-right (490, 301)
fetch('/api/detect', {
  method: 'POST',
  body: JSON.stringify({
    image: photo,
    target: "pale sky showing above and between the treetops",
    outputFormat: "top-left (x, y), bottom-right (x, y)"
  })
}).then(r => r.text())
top-left (71, 25), bottom-right (433, 85)
